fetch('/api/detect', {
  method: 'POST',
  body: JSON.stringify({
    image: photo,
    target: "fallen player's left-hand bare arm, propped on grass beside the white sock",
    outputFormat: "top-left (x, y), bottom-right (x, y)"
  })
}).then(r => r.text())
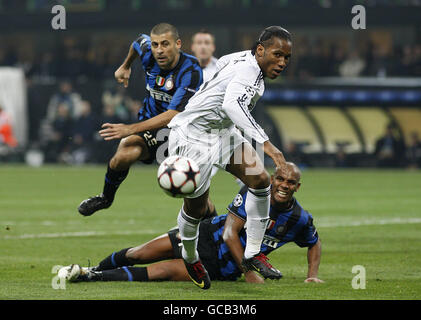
top-left (222, 213), bottom-right (264, 283)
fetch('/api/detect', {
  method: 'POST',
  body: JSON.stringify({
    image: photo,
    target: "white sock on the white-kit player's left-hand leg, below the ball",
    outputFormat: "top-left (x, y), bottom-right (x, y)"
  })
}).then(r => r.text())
top-left (177, 207), bottom-right (200, 263)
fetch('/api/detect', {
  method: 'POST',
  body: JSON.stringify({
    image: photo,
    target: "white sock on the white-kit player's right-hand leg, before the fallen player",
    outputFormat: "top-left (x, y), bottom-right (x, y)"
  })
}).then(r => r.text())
top-left (244, 186), bottom-right (270, 259)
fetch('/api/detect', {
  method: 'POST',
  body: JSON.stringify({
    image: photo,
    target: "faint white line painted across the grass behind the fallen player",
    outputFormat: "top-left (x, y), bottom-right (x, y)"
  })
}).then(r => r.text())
top-left (2, 218), bottom-right (421, 240)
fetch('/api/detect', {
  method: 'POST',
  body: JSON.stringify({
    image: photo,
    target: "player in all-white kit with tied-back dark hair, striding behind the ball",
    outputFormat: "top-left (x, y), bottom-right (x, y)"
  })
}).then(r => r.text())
top-left (168, 26), bottom-right (292, 289)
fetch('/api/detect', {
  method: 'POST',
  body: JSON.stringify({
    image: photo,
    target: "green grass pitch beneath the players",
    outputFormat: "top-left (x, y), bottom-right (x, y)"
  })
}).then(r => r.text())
top-left (0, 165), bottom-right (421, 300)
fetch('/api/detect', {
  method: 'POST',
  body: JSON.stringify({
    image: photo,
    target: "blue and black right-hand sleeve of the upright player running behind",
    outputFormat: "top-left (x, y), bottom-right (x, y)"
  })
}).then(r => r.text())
top-left (168, 65), bottom-right (203, 112)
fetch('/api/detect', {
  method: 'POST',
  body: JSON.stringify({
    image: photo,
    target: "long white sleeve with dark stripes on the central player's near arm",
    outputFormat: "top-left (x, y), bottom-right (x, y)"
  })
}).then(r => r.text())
top-left (222, 68), bottom-right (269, 143)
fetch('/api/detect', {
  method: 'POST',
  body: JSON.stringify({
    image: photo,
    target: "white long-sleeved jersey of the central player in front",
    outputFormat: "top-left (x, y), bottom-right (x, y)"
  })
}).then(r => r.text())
top-left (168, 50), bottom-right (269, 143)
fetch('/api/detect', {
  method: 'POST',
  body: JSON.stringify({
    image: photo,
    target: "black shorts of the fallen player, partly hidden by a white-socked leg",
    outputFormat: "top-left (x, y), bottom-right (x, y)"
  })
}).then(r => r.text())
top-left (168, 219), bottom-right (226, 280)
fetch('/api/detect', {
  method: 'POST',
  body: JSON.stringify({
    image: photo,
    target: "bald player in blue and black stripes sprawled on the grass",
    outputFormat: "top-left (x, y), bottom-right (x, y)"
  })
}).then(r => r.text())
top-left (64, 162), bottom-right (323, 283)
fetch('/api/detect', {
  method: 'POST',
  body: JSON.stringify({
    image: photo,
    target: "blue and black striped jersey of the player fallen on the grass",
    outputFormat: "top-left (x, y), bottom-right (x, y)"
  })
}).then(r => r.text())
top-left (209, 187), bottom-right (319, 280)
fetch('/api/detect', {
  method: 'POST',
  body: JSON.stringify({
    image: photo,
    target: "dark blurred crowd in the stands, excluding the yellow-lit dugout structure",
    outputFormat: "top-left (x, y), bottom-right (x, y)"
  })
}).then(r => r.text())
top-left (0, 0), bottom-right (421, 167)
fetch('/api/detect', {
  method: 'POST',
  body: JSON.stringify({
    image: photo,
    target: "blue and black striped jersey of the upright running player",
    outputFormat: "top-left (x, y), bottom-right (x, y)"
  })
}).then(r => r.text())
top-left (132, 34), bottom-right (203, 121)
